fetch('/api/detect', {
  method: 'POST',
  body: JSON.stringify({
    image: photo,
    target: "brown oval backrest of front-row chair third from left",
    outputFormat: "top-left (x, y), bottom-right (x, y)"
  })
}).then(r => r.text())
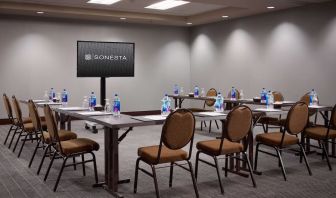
top-left (285, 102), bottom-right (309, 135)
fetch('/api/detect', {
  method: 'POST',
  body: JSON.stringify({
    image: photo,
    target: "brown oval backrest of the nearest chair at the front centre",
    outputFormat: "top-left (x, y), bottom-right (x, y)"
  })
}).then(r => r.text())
top-left (161, 109), bottom-right (195, 150)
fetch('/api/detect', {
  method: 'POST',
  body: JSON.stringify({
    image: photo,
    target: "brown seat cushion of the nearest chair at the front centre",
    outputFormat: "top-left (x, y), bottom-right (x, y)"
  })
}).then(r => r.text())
top-left (138, 146), bottom-right (188, 164)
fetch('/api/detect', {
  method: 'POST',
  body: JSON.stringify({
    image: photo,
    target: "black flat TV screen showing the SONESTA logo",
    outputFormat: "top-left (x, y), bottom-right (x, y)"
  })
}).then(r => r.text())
top-left (77, 41), bottom-right (134, 77)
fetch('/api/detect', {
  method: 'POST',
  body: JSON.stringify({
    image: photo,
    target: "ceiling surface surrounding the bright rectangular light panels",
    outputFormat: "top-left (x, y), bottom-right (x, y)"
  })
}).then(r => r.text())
top-left (0, 0), bottom-right (328, 26)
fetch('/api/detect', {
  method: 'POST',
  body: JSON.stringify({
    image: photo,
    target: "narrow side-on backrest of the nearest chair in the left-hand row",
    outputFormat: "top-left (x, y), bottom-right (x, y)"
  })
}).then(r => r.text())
top-left (43, 104), bottom-right (62, 145)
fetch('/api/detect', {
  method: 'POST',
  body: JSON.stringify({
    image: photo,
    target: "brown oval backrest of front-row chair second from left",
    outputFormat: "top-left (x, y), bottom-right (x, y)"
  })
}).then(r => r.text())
top-left (222, 105), bottom-right (252, 142)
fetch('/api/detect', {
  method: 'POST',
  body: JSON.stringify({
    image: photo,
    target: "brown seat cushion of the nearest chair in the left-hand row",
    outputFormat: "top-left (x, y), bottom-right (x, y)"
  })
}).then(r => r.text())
top-left (57, 138), bottom-right (99, 155)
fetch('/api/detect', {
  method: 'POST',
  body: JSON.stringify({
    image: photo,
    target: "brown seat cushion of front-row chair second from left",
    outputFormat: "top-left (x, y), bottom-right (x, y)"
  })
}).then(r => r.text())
top-left (196, 139), bottom-right (244, 155)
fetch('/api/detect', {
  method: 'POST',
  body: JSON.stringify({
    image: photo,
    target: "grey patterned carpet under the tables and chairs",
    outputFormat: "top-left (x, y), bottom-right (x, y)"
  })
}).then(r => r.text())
top-left (0, 121), bottom-right (336, 198)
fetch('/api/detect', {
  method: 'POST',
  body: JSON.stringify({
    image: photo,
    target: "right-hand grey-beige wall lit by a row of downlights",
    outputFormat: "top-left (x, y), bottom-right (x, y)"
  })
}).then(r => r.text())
top-left (190, 2), bottom-right (336, 104)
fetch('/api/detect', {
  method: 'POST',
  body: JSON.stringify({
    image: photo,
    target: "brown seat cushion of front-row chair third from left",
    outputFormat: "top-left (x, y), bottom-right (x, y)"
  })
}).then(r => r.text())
top-left (256, 132), bottom-right (299, 146)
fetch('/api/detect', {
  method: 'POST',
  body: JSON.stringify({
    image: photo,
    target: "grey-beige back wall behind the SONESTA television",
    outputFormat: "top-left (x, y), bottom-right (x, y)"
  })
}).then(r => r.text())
top-left (0, 17), bottom-right (190, 118)
